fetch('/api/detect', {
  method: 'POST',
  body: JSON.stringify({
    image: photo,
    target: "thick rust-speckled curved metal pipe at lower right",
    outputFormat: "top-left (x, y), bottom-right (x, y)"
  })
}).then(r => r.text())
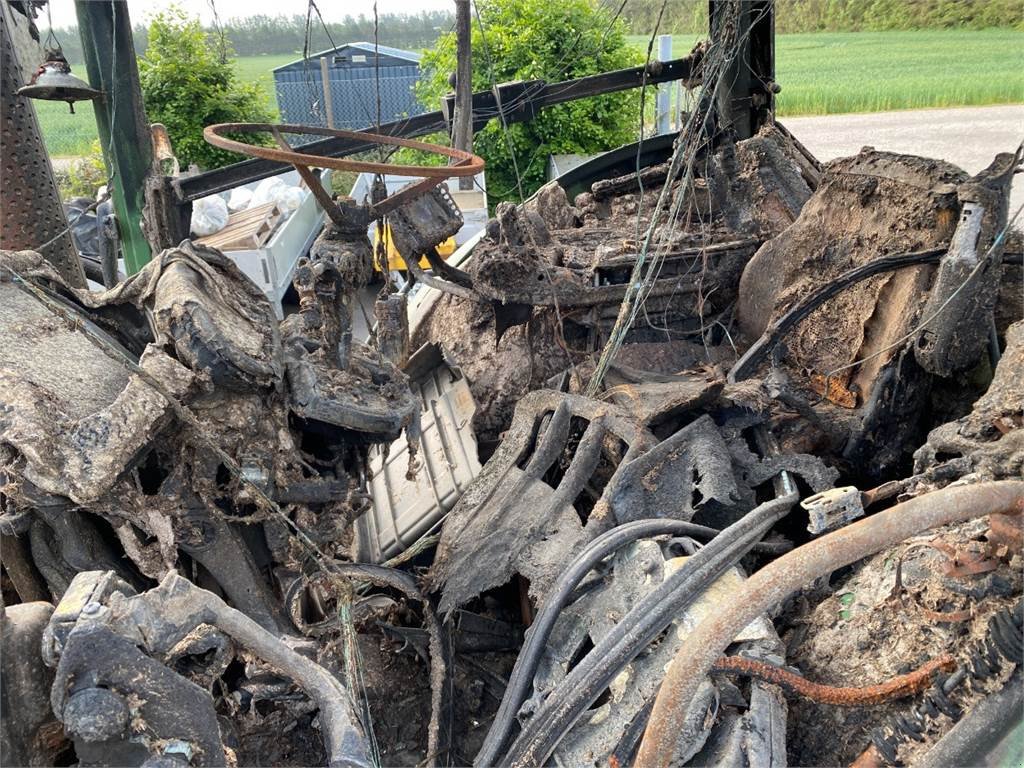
top-left (636, 480), bottom-right (1024, 768)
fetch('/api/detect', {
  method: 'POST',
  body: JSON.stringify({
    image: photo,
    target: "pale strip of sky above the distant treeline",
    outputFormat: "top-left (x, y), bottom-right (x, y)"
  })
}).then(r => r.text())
top-left (44, 0), bottom-right (455, 29)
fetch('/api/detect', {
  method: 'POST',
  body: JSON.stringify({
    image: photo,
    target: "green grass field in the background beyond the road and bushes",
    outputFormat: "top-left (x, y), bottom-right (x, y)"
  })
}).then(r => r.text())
top-left (36, 30), bottom-right (1024, 157)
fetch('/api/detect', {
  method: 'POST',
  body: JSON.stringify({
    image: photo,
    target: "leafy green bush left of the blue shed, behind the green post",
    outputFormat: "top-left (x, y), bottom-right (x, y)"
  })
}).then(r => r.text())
top-left (138, 6), bottom-right (273, 169)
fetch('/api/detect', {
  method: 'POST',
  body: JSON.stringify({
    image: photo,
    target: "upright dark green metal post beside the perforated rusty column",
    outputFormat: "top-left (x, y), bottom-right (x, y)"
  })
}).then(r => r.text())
top-left (75, 0), bottom-right (153, 274)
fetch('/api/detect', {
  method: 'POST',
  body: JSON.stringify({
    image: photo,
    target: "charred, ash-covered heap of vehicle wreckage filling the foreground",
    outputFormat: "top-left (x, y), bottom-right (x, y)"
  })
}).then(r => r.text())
top-left (0, 18), bottom-right (1024, 768)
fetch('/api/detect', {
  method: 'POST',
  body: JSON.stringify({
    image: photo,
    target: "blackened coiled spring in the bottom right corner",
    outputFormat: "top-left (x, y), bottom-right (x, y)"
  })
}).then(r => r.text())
top-left (871, 601), bottom-right (1024, 765)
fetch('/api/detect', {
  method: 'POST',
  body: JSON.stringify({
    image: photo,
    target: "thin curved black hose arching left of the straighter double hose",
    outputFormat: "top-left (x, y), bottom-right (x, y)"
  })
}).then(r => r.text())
top-left (473, 519), bottom-right (774, 766)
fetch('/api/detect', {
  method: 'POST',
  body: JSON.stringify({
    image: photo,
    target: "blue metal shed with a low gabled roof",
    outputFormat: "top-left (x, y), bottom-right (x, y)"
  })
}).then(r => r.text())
top-left (273, 43), bottom-right (426, 133)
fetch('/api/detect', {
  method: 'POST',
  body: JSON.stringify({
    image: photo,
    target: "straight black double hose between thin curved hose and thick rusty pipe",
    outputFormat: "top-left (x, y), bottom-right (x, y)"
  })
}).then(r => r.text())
top-left (495, 493), bottom-right (798, 766)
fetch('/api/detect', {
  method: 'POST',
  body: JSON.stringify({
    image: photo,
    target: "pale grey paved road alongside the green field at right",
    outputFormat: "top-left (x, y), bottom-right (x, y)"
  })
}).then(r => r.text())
top-left (779, 104), bottom-right (1024, 218)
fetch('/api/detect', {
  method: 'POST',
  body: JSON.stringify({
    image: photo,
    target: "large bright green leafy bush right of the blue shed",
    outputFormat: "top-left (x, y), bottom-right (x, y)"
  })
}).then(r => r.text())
top-left (417, 0), bottom-right (638, 202)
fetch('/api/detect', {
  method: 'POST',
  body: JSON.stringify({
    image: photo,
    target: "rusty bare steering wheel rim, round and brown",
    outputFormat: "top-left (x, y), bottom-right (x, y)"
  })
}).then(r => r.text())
top-left (203, 123), bottom-right (483, 181)
